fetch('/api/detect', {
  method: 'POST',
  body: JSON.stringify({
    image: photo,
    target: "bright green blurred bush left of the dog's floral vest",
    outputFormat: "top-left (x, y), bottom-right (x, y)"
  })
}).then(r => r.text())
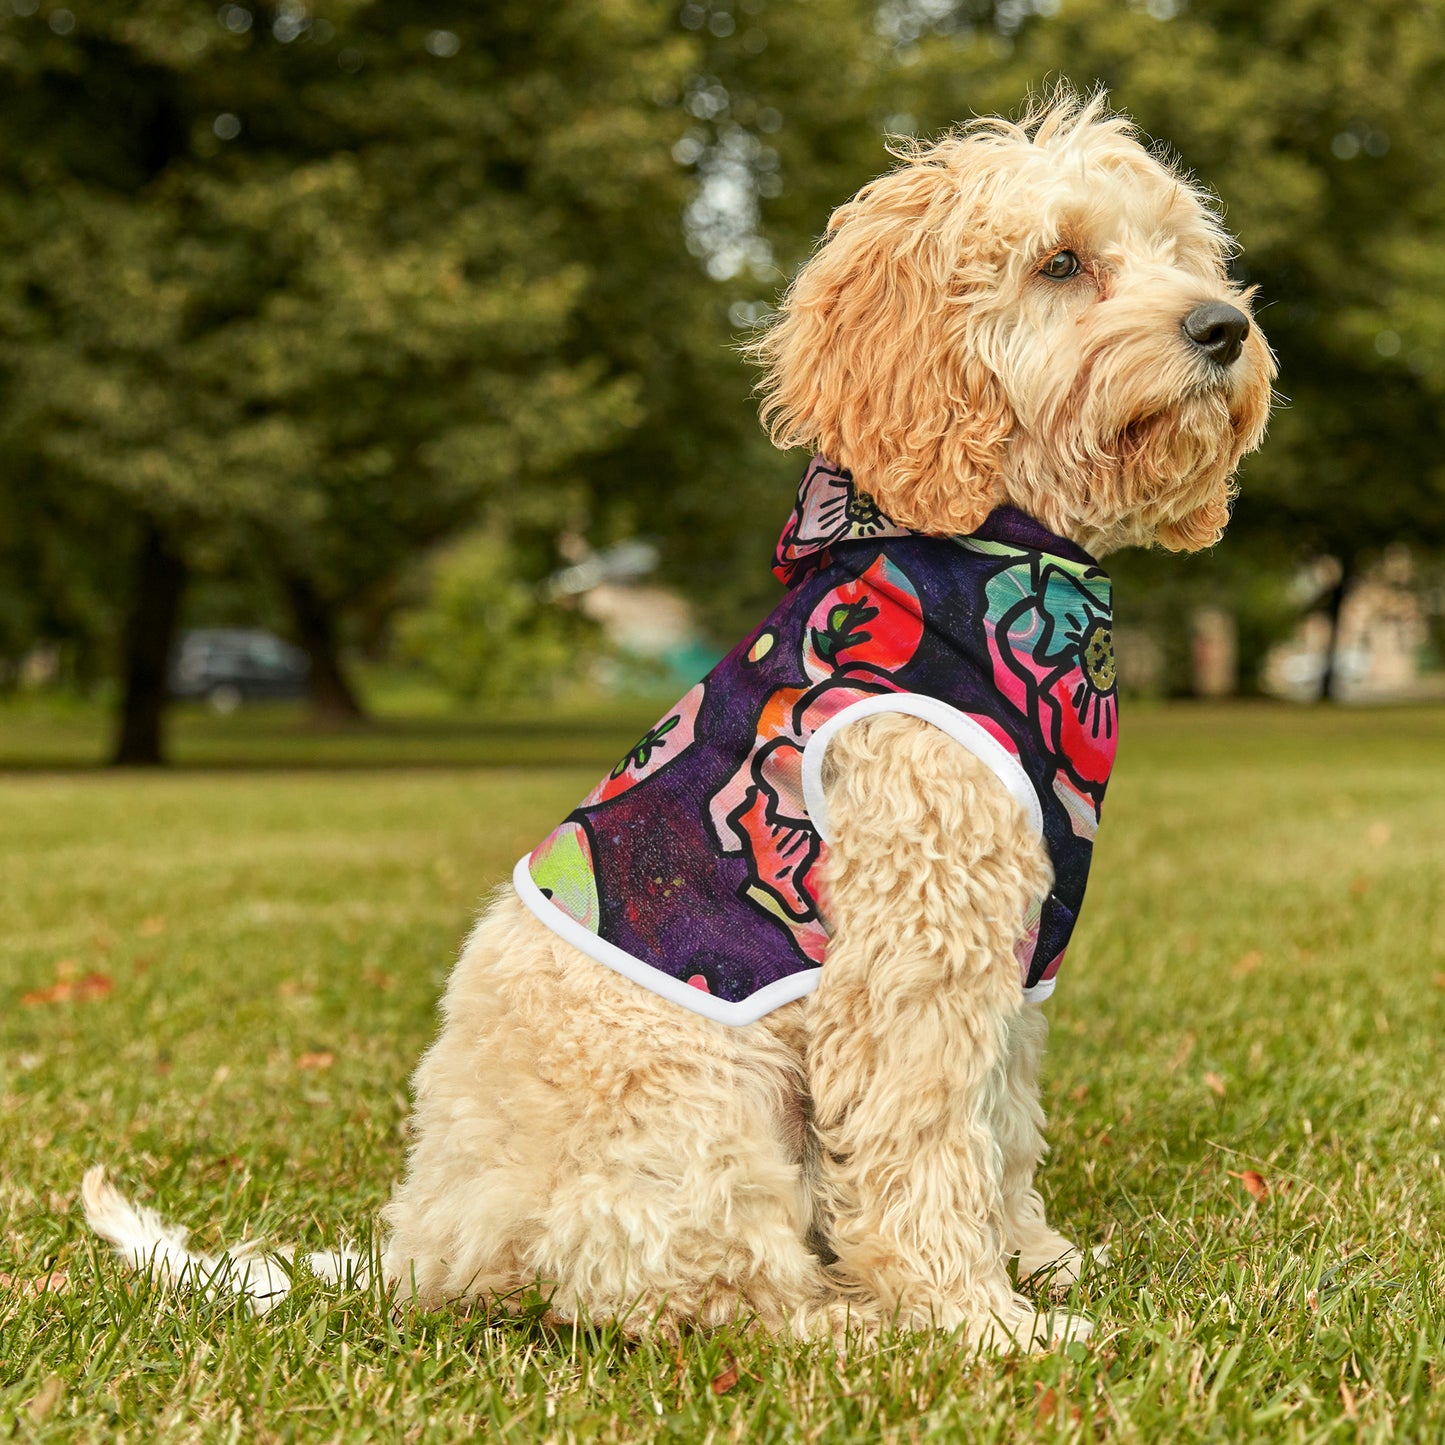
top-left (396, 532), bottom-right (600, 702)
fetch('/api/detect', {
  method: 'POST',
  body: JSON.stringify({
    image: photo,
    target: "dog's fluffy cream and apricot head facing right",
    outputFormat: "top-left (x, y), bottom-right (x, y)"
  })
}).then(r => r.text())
top-left (753, 94), bottom-right (1274, 552)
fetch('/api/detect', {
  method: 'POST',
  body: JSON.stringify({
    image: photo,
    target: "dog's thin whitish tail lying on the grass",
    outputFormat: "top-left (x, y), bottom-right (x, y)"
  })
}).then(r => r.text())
top-left (81, 1165), bottom-right (371, 1315)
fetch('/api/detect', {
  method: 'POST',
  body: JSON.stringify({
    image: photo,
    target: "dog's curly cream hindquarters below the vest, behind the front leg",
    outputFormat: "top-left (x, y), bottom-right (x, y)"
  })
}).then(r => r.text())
top-left (384, 896), bottom-right (824, 1335)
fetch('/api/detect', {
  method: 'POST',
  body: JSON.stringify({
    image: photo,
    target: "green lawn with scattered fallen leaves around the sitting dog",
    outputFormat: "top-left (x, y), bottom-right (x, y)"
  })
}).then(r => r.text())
top-left (0, 696), bottom-right (1445, 1442)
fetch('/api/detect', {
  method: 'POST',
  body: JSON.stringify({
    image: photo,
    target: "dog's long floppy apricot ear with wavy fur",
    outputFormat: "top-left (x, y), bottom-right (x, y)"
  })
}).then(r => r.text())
top-left (749, 148), bottom-right (1013, 533)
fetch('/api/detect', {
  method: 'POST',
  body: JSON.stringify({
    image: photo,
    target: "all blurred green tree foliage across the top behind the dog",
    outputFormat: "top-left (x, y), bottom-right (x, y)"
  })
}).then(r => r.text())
top-left (0, 0), bottom-right (1445, 699)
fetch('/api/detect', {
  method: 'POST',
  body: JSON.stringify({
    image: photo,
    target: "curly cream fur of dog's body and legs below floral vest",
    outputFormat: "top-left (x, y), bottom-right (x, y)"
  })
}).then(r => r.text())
top-left (383, 728), bottom-right (1084, 1344)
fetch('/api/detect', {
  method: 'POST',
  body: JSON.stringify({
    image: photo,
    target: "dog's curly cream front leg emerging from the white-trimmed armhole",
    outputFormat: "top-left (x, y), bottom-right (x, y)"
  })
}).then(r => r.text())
top-left (808, 715), bottom-right (1088, 1347)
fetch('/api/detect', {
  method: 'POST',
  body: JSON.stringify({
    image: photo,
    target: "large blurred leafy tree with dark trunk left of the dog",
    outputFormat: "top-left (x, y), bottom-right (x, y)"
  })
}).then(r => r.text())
top-left (0, 0), bottom-right (688, 763)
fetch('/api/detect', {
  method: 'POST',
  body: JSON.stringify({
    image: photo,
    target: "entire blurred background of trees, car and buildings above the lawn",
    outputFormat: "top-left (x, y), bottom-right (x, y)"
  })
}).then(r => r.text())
top-left (0, 0), bottom-right (1445, 764)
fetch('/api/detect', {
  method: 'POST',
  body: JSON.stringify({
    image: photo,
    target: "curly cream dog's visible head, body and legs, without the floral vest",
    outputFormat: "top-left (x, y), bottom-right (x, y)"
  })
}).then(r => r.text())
top-left (87, 95), bottom-right (1273, 1345)
